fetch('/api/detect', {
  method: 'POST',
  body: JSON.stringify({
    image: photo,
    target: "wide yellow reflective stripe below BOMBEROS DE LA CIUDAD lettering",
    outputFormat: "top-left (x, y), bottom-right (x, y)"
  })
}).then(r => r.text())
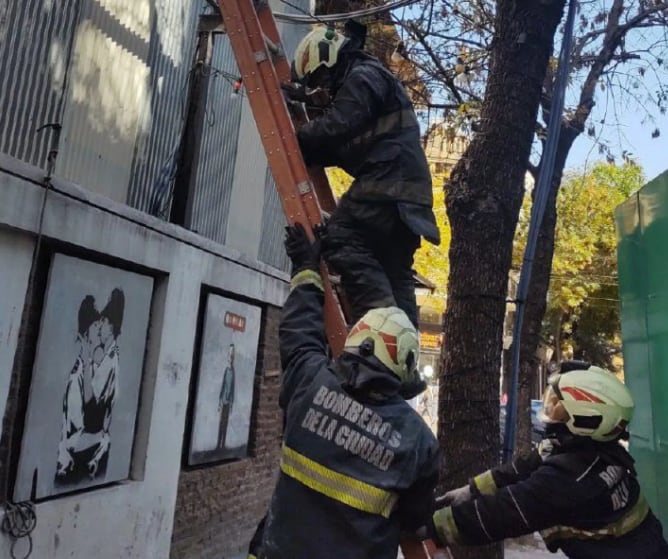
top-left (281, 445), bottom-right (398, 518)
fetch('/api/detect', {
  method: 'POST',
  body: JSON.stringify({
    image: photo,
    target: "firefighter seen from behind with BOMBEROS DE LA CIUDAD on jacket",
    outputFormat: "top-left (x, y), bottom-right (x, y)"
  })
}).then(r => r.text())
top-left (258, 226), bottom-right (439, 559)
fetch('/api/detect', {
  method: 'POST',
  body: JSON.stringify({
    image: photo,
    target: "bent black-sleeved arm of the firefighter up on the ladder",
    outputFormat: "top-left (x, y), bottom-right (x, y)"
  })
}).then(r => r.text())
top-left (297, 68), bottom-right (388, 166)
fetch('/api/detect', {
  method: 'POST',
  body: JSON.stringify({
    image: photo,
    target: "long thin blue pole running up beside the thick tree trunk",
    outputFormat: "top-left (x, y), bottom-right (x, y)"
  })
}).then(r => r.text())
top-left (503, 0), bottom-right (578, 462)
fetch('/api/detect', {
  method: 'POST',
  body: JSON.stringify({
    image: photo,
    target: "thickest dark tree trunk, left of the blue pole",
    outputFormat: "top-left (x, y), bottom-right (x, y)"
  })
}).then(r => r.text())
top-left (438, 0), bottom-right (564, 559)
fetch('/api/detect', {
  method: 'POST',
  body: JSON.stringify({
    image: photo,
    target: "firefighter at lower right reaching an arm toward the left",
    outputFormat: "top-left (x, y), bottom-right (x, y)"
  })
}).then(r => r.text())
top-left (433, 367), bottom-right (668, 559)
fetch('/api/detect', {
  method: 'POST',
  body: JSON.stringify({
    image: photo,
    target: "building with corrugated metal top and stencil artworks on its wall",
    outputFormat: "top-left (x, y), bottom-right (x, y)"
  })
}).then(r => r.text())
top-left (0, 0), bottom-right (309, 559)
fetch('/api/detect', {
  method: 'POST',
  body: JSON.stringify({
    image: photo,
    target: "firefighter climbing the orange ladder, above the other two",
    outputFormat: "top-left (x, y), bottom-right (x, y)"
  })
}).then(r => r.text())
top-left (286, 26), bottom-right (440, 328)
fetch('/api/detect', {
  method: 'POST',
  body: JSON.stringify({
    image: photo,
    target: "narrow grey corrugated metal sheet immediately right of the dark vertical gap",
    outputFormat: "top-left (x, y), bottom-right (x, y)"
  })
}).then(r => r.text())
top-left (190, 35), bottom-right (243, 243)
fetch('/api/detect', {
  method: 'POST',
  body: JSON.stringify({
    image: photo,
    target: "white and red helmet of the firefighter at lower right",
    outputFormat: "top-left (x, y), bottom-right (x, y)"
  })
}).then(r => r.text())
top-left (540, 367), bottom-right (634, 442)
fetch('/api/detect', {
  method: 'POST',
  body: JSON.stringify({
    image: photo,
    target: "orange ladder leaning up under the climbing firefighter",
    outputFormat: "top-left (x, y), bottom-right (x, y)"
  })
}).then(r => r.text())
top-left (219, 0), bottom-right (448, 559)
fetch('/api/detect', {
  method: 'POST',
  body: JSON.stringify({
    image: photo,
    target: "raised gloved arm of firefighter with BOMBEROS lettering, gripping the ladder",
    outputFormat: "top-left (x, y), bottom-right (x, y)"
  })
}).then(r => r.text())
top-left (278, 224), bottom-right (328, 408)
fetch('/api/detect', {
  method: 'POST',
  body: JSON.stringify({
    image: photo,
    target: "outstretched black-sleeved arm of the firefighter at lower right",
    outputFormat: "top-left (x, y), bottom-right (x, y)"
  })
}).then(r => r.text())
top-left (433, 466), bottom-right (582, 545)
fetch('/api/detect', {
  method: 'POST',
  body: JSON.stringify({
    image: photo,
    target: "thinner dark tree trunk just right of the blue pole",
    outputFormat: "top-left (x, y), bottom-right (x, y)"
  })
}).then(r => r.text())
top-left (515, 130), bottom-right (578, 452)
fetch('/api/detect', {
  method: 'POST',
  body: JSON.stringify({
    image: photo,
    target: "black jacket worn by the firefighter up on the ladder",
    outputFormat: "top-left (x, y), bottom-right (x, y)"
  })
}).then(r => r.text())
top-left (298, 51), bottom-right (440, 244)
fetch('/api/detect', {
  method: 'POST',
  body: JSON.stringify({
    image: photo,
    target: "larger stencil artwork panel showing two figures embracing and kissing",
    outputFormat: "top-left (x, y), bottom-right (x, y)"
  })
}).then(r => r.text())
top-left (14, 254), bottom-right (153, 501)
